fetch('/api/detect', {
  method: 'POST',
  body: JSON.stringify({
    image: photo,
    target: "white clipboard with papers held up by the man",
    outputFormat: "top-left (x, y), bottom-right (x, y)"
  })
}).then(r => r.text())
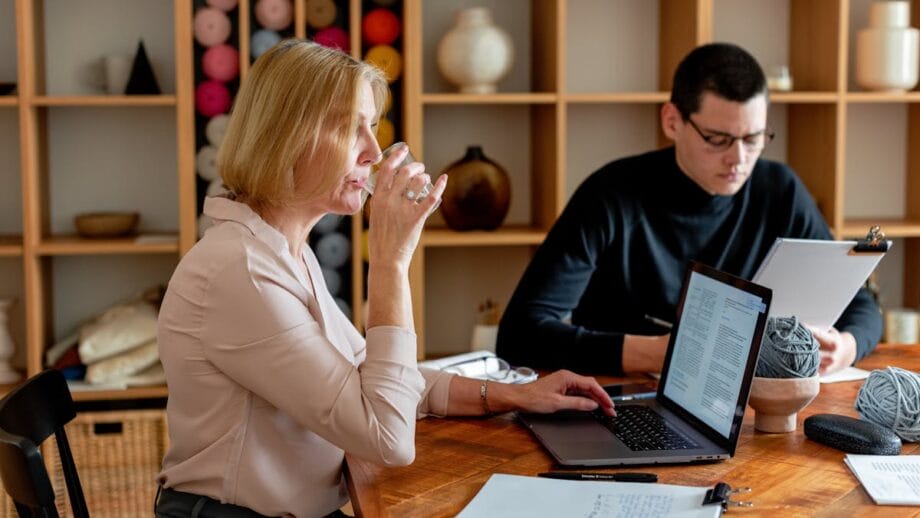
top-left (752, 238), bottom-right (891, 329)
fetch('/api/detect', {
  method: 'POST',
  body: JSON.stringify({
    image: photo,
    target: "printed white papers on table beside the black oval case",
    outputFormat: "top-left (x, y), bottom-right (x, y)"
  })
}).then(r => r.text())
top-left (844, 454), bottom-right (920, 505)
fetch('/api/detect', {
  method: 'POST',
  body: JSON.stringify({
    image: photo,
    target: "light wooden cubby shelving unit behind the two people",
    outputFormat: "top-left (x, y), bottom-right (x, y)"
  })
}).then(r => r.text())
top-left (0, 0), bottom-right (920, 394)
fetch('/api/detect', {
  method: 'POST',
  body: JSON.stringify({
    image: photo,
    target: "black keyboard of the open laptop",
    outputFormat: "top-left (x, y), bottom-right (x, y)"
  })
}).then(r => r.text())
top-left (594, 405), bottom-right (700, 451)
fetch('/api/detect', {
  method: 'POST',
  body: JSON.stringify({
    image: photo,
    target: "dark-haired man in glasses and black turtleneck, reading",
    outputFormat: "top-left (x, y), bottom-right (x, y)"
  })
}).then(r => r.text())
top-left (497, 44), bottom-right (881, 374)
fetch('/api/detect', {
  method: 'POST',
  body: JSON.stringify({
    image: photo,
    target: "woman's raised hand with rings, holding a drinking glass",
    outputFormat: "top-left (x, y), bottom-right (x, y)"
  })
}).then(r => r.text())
top-left (368, 145), bottom-right (447, 271)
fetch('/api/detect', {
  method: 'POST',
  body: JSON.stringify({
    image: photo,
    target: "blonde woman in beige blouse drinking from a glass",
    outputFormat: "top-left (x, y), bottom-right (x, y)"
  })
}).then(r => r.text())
top-left (157, 40), bottom-right (613, 516)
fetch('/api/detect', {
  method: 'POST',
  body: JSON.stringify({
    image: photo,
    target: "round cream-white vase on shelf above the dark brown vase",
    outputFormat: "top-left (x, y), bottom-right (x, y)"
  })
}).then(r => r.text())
top-left (438, 7), bottom-right (514, 94)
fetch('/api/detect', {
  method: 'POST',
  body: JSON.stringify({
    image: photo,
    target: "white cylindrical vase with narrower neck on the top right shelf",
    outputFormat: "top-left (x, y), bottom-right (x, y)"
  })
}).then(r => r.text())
top-left (856, 1), bottom-right (920, 91)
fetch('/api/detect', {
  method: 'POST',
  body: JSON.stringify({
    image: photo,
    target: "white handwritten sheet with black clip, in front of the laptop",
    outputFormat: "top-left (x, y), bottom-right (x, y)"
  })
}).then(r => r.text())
top-left (457, 474), bottom-right (721, 518)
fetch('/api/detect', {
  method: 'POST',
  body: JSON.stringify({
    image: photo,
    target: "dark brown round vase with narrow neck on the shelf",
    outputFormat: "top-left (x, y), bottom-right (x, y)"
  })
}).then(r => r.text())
top-left (441, 146), bottom-right (511, 234)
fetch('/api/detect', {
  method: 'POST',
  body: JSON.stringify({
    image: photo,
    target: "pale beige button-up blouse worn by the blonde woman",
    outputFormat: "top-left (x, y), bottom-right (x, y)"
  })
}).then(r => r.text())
top-left (158, 198), bottom-right (451, 516)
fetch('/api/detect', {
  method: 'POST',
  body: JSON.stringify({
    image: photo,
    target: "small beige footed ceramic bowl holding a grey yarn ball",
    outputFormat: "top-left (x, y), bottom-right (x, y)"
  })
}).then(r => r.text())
top-left (748, 376), bottom-right (821, 433)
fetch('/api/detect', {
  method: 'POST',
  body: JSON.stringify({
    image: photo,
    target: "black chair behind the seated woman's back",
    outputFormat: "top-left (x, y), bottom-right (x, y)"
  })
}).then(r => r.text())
top-left (0, 370), bottom-right (89, 517)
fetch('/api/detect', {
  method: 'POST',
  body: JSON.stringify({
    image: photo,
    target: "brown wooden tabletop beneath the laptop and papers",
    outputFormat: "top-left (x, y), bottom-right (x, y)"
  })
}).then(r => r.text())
top-left (347, 345), bottom-right (920, 518)
